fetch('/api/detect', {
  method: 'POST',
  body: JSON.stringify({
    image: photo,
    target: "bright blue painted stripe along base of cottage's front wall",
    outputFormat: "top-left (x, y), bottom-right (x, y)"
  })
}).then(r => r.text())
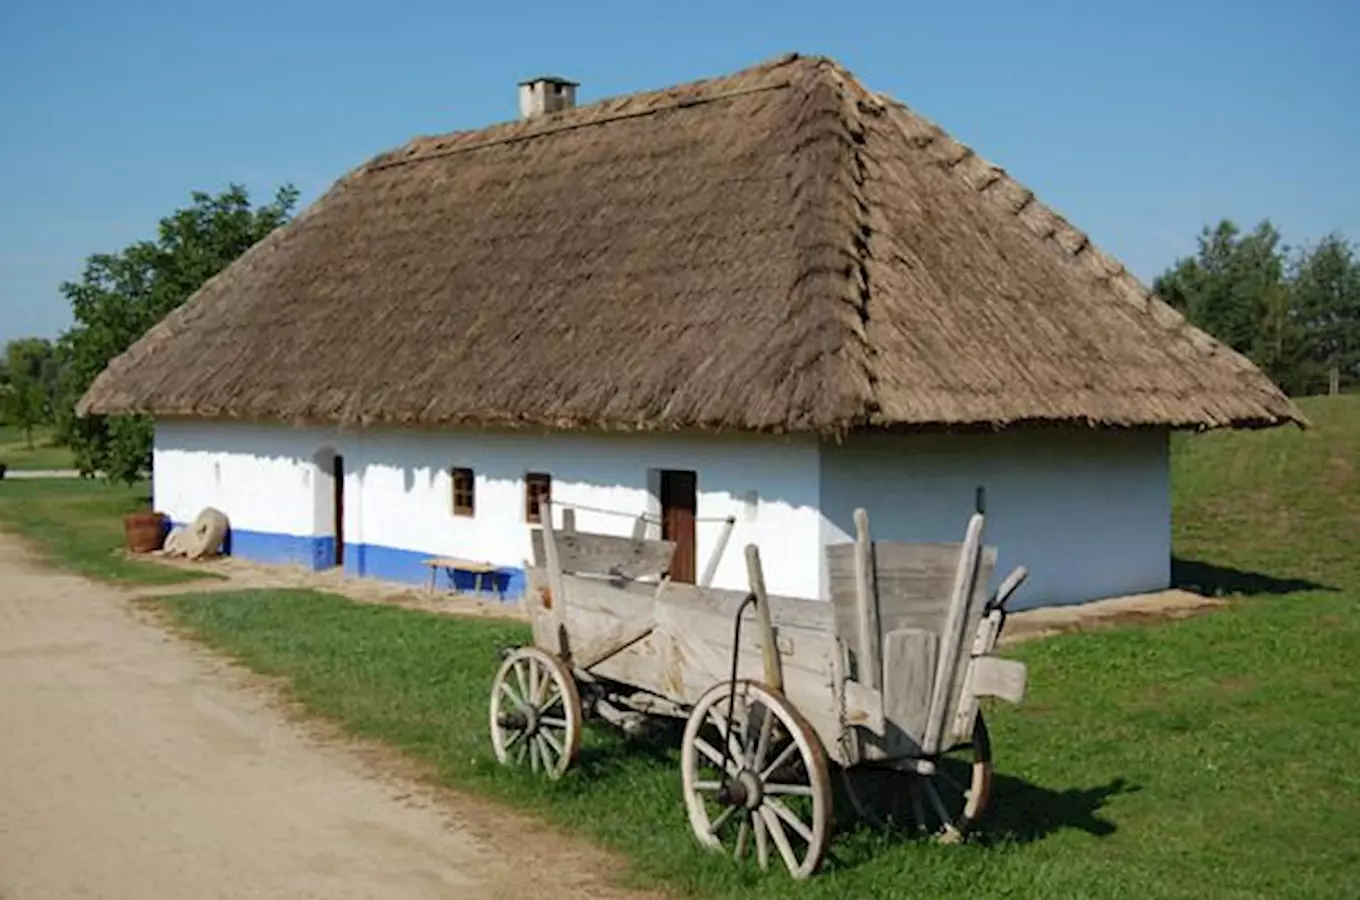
top-left (174, 522), bottom-right (525, 601)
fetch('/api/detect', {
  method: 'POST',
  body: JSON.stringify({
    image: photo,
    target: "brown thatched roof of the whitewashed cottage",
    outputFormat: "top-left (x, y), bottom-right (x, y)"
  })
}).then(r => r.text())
top-left (82, 57), bottom-right (1303, 434)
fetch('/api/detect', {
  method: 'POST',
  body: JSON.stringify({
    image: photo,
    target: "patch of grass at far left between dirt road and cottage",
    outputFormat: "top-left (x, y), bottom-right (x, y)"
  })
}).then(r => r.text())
top-left (0, 479), bottom-right (204, 585)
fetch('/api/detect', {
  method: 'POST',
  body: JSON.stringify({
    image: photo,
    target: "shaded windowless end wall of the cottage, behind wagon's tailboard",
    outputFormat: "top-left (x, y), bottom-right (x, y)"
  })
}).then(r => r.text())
top-left (820, 431), bottom-right (1171, 608)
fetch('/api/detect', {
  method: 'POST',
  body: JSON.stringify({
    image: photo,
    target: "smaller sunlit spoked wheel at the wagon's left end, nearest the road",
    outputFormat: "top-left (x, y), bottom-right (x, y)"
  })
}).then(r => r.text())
top-left (491, 647), bottom-right (581, 778)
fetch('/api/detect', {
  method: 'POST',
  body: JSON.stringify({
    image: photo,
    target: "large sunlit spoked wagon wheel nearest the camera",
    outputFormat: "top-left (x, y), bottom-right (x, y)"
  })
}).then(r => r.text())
top-left (680, 681), bottom-right (832, 878)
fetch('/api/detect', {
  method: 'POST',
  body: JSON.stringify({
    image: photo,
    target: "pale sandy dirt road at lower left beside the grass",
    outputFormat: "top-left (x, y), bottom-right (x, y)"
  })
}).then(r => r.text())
top-left (0, 534), bottom-right (658, 900)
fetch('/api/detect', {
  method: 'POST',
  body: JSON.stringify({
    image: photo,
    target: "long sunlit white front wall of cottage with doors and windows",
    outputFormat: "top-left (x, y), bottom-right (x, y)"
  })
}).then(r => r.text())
top-left (155, 420), bottom-right (821, 594)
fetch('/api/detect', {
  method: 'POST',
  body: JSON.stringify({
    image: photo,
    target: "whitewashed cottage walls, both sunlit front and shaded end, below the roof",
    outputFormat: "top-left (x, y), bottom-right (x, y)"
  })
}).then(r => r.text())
top-left (155, 420), bottom-right (1171, 606)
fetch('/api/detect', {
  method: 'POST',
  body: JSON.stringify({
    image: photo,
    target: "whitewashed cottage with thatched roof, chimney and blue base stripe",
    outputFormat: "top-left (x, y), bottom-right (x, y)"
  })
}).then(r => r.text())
top-left (82, 56), bottom-right (1302, 605)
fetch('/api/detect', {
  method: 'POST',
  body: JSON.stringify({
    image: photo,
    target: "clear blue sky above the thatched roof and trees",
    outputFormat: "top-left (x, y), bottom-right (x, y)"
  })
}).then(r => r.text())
top-left (0, 0), bottom-right (1360, 346)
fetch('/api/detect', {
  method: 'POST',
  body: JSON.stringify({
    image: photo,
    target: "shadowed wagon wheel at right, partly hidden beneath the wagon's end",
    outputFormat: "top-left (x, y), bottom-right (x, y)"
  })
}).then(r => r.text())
top-left (842, 712), bottom-right (991, 843)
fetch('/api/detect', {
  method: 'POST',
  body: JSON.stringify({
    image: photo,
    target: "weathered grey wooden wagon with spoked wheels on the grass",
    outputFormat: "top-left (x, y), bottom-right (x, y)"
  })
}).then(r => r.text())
top-left (491, 497), bottom-right (1025, 877)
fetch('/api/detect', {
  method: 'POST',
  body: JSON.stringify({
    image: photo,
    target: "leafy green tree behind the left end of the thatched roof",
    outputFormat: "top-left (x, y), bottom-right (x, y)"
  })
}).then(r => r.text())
top-left (57, 179), bottom-right (298, 481)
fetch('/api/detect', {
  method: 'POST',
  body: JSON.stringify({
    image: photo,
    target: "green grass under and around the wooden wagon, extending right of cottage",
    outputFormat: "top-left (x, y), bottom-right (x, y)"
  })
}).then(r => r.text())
top-left (15, 397), bottom-right (1360, 900)
